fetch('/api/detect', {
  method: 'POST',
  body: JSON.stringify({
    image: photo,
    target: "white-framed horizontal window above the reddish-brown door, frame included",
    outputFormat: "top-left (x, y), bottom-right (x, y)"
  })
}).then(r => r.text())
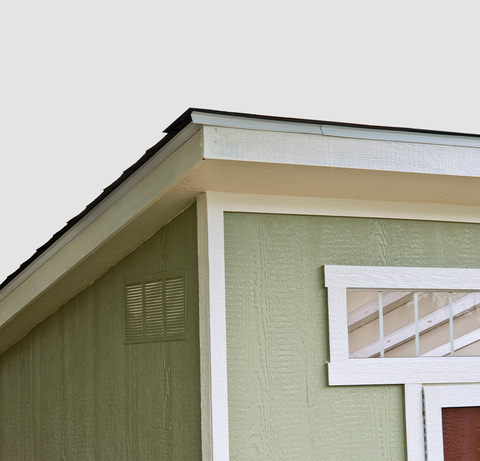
top-left (325, 266), bottom-right (480, 385)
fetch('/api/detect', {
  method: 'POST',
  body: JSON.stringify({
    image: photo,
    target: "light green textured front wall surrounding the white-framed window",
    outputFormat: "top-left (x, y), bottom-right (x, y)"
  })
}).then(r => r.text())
top-left (225, 213), bottom-right (480, 461)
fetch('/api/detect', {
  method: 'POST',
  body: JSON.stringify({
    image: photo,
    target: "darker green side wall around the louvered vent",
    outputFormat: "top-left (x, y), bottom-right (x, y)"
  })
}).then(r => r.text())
top-left (0, 206), bottom-right (201, 461)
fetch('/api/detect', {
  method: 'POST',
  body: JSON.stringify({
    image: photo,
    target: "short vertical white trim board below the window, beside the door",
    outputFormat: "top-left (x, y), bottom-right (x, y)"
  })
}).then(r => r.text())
top-left (405, 383), bottom-right (425, 461)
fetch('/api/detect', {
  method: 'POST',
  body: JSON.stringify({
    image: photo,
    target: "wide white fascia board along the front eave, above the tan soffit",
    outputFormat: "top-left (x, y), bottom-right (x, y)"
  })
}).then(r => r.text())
top-left (204, 126), bottom-right (480, 178)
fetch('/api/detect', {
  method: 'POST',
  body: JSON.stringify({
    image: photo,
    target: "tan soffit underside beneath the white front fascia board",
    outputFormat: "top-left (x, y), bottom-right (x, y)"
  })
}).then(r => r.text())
top-left (178, 159), bottom-right (480, 206)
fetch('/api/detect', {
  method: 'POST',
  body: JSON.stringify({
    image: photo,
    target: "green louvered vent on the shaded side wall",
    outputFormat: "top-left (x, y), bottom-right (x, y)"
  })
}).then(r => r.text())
top-left (125, 272), bottom-right (187, 343)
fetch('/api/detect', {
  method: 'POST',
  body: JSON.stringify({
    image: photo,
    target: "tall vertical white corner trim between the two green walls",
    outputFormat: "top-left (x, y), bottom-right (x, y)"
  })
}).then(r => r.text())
top-left (197, 193), bottom-right (229, 461)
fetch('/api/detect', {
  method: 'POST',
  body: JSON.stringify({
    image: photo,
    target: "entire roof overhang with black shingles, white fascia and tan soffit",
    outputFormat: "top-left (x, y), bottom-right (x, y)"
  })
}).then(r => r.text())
top-left (0, 109), bottom-right (480, 352)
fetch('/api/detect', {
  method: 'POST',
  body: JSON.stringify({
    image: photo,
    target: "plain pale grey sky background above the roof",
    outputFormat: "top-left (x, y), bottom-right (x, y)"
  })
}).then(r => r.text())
top-left (0, 0), bottom-right (480, 280)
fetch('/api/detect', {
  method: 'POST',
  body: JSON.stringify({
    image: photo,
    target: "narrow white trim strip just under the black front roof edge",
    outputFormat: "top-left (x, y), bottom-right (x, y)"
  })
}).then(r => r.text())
top-left (191, 111), bottom-right (480, 147)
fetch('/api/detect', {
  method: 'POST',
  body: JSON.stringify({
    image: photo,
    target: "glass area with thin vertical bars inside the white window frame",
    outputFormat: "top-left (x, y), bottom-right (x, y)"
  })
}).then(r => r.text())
top-left (347, 290), bottom-right (480, 358)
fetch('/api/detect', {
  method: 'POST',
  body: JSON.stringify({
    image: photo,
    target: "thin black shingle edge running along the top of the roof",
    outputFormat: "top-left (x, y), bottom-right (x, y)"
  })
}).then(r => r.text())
top-left (0, 108), bottom-right (480, 291)
